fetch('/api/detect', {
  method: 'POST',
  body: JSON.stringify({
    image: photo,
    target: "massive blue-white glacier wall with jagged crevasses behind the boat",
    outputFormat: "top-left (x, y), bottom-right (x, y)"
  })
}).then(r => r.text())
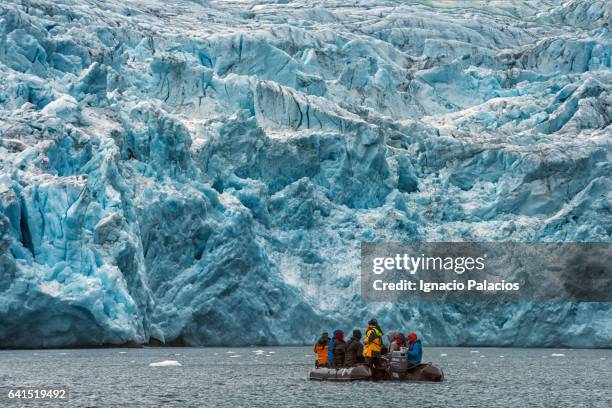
top-left (0, 0), bottom-right (612, 348)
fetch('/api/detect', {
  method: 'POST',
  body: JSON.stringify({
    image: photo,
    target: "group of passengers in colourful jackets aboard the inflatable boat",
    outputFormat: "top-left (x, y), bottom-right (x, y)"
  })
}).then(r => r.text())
top-left (313, 319), bottom-right (423, 368)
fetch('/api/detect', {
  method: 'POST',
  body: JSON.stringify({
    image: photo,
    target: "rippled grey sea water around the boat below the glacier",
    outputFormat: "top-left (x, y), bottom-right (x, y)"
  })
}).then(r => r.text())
top-left (0, 347), bottom-right (612, 407)
